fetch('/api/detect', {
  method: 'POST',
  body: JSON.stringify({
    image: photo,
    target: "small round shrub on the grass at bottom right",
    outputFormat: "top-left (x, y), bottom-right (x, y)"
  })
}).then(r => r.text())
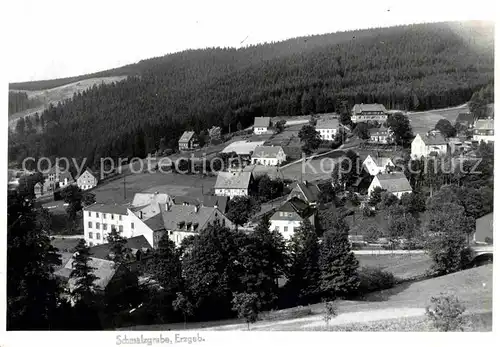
top-left (425, 294), bottom-right (465, 331)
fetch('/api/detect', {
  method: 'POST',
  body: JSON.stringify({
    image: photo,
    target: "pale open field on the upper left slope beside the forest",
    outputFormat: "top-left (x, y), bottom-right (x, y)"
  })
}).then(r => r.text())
top-left (9, 76), bottom-right (127, 126)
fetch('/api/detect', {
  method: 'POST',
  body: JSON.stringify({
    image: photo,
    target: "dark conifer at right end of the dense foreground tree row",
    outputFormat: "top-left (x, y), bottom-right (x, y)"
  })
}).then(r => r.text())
top-left (319, 218), bottom-right (359, 299)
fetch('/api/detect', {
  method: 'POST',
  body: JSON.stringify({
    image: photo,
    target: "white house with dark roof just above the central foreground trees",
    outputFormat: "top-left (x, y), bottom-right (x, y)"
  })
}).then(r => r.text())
top-left (269, 197), bottom-right (316, 240)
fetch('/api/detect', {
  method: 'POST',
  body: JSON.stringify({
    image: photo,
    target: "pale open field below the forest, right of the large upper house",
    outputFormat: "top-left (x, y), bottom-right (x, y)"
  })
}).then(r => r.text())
top-left (408, 104), bottom-right (469, 134)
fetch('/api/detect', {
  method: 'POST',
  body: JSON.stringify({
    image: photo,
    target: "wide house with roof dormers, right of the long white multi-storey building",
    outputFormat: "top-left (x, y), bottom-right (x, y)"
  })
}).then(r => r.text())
top-left (161, 204), bottom-right (234, 247)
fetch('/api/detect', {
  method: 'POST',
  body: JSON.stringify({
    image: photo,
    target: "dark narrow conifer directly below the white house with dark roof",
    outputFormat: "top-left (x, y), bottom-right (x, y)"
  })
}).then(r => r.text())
top-left (287, 219), bottom-right (320, 304)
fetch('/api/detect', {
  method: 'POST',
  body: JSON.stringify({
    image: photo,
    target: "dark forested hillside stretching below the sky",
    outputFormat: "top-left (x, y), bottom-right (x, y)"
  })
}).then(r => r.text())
top-left (9, 22), bottom-right (494, 169)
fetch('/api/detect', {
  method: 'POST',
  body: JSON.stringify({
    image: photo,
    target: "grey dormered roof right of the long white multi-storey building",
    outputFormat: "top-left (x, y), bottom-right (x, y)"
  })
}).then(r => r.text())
top-left (161, 205), bottom-right (222, 231)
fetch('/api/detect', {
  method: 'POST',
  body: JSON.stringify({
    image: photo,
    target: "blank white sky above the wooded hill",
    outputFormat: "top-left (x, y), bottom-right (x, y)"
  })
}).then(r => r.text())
top-left (1, 0), bottom-right (496, 82)
